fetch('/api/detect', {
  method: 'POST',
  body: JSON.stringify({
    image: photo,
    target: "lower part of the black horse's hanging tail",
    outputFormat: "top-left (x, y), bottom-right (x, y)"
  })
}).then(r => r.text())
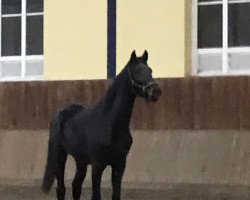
top-left (42, 138), bottom-right (55, 193)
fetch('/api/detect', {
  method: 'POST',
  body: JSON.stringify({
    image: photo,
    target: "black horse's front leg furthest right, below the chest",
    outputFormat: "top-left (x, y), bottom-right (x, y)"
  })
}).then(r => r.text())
top-left (112, 159), bottom-right (126, 200)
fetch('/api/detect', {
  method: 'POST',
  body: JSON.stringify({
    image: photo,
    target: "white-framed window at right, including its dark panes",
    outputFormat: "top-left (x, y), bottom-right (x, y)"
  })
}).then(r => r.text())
top-left (196, 0), bottom-right (250, 75)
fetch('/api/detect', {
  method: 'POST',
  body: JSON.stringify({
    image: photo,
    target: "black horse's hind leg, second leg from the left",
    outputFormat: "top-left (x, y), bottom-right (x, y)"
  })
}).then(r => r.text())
top-left (72, 160), bottom-right (87, 200)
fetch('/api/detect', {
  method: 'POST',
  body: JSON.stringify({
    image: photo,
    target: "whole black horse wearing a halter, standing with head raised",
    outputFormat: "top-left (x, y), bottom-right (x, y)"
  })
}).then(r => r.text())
top-left (42, 51), bottom-right (161, 200)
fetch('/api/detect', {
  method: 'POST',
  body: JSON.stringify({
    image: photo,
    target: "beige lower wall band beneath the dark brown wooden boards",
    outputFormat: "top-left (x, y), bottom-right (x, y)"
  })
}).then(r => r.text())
top-left (0, 130), bottom-right (250, 189)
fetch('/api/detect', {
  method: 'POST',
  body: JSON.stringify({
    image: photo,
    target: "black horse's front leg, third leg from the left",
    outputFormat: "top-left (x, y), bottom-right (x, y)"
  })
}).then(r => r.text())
top-left (91, 164), bottom-right (106, 200)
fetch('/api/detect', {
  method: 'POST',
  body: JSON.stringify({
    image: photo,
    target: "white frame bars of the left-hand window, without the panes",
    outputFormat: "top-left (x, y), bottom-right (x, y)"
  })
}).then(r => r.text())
top-left (0, 0), bottom-right (44, 82)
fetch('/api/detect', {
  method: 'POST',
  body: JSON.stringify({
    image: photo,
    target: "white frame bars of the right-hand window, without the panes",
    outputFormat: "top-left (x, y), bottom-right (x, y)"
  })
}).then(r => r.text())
top-left (192, 0), bottom-right (250, 76)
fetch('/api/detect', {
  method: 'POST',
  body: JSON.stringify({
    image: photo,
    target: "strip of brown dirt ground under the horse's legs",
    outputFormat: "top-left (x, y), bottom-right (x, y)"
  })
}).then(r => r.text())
top-left (0, 185), bottom-right (250, 200)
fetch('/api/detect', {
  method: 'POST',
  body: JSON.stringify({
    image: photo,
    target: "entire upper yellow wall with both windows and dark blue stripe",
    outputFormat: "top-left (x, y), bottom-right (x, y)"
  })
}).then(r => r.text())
top-left (0, 0), bottom-right (250, 81)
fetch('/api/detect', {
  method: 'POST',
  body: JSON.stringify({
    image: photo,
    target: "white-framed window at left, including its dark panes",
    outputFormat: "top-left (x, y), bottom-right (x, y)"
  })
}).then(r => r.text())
top-left (0, 0), bottom-right (43, 81)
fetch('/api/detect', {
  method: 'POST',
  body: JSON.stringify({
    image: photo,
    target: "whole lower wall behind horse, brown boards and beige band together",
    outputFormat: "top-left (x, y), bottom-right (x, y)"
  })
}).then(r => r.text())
top-left (0, 77), bottom-right (250, 189)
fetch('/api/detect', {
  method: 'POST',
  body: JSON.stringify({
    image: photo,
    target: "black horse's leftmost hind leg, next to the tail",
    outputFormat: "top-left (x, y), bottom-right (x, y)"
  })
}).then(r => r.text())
top-left (54, 145), bottom-right (67, 200)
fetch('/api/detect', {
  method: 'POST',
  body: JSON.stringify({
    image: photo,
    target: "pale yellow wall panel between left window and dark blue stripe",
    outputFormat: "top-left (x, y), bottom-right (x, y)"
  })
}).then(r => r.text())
top-left (44, 0), bottom-right (107, 80)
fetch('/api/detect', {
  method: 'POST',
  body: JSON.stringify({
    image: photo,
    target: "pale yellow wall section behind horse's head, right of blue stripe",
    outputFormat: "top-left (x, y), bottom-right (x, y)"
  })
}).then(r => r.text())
top-left (117, 0), bottom-right (191, 78)
